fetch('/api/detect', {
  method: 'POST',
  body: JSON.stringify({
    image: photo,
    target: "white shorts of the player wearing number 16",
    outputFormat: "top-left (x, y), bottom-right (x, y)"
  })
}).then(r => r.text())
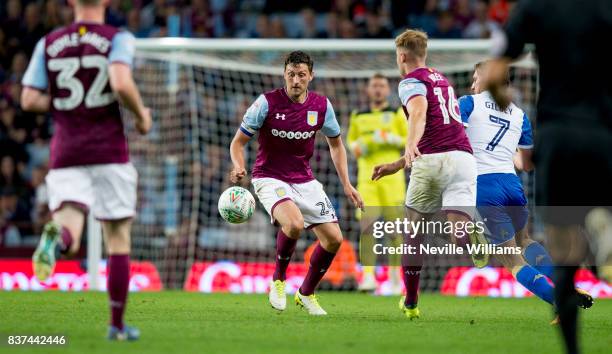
top-left (406, 151), bottom-right (478, 217)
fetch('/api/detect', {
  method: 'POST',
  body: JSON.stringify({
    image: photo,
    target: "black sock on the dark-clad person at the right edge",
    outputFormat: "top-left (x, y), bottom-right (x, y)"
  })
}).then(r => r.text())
top-left (554, 266), bottom-right (578, 354)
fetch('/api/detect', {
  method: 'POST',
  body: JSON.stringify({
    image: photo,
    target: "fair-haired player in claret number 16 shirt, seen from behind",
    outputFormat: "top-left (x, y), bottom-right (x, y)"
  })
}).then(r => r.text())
top-left (372, 30), bottom-right (487, 319)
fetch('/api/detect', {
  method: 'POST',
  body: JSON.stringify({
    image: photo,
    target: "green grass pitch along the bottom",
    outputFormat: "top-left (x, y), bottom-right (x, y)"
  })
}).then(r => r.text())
top-left (0, 291), bottom-right (612, 354)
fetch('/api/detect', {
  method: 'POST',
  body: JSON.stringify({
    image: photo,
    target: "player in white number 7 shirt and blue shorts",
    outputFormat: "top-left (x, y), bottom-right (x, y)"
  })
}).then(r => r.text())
top-left (459, 62), bottom-right (593, 323)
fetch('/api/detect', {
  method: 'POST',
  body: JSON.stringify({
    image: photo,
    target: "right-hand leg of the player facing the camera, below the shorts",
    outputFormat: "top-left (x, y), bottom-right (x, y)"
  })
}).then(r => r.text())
top-left (295, 223), bottom-right (342, 315)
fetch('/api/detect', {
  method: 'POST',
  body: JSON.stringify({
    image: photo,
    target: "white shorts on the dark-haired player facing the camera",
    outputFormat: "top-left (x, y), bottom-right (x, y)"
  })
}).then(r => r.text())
top-left (253, 177), bottom-right (338, 229)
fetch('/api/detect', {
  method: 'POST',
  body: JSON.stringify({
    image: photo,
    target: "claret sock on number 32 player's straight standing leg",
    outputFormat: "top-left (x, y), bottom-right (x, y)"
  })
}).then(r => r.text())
top-left (107, 254), bottom-right (130, 330)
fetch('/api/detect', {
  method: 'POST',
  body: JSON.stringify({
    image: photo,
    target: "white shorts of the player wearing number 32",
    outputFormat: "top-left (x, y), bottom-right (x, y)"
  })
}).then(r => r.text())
top-left (45, 163), bottom-right (138, 220)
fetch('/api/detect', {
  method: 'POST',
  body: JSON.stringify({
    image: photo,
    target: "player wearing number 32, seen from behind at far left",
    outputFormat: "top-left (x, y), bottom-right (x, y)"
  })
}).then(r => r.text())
top-left (21, 0), bottom-right (151, 340)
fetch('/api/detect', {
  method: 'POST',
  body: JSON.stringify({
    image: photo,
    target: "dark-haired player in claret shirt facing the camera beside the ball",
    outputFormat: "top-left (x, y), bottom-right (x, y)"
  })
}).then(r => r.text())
top-left (230, 51), bottom-right (363, 315)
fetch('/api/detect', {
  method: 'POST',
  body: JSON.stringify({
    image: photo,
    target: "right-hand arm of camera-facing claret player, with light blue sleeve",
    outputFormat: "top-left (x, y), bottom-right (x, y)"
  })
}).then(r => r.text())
top-left (321, 100), bottom-right (363, 209)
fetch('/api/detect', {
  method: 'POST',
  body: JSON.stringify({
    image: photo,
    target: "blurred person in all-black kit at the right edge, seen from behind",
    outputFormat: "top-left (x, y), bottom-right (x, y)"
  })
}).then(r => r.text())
top-left (487, 0), bottom-right (612, 353)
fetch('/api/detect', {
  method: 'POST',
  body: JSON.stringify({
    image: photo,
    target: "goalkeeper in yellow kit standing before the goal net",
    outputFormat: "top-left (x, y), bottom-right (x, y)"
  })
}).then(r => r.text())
top-left (348, 74), bottom-right (408, 294)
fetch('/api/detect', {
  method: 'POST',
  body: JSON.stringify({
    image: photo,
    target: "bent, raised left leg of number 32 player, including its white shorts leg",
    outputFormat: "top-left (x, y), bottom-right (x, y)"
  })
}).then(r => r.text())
top-left (32, 167), bottom-right (94, 281)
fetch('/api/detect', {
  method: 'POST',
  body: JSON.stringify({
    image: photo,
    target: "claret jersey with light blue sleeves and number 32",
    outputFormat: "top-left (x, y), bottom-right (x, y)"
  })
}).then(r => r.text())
top-left (22, 22), bottom-right (134, 168)
